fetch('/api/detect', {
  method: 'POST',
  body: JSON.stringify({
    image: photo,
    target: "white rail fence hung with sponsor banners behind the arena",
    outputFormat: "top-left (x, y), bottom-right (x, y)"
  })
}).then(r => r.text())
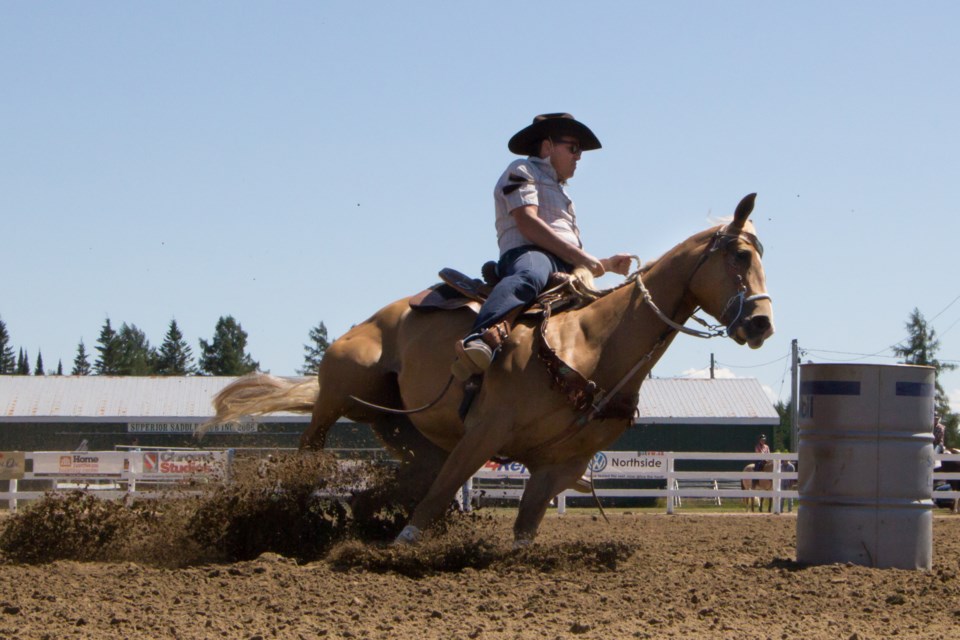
top-left (0, 449), bottom-right (960, 513)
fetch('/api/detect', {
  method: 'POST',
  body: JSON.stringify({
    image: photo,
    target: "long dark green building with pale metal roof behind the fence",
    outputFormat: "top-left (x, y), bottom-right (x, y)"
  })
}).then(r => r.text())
top-left (0, 375), bottom-right (780, 451)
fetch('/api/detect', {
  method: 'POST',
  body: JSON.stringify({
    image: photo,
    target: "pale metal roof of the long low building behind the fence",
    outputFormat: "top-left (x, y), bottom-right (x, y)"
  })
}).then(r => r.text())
top-left (0, 375), bottom-right (780, 425)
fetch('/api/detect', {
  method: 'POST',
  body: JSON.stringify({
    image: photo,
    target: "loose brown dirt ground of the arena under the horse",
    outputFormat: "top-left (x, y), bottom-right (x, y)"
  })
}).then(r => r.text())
top-left (0, 509), bottom-right (960, 640)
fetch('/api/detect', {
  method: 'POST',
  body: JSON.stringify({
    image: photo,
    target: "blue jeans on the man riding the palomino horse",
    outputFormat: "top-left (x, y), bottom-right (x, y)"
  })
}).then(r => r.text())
top-left (470, 244), bottom-right (573, 335)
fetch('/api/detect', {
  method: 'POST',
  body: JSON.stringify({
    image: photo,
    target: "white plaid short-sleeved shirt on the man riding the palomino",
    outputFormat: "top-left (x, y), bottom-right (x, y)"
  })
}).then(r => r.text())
top-left (493, 156), bottom-right (583, 255)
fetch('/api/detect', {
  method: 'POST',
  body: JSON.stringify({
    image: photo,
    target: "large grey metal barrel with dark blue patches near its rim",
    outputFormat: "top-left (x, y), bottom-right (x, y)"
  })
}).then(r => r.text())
top-left (797, 364), bottom-right (936, 569)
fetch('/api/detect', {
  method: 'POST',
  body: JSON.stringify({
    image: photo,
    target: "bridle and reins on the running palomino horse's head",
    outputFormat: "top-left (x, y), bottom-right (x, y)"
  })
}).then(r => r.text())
top-left (632, 227), bottom-right (772, 338)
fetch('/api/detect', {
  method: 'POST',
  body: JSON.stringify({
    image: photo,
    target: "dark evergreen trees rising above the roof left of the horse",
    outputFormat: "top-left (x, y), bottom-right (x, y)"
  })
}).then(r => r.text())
top-left (0, 316), bottom-right (330, 376)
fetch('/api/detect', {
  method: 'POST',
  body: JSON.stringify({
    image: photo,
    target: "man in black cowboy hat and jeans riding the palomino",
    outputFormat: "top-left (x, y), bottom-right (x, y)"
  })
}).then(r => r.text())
top-left (453, 113), bottom-right (631, 380)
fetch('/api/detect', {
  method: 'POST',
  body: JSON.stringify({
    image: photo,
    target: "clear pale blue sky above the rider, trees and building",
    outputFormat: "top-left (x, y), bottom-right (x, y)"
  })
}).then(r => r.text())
top-left (0, 1), bottom-right (960, 407)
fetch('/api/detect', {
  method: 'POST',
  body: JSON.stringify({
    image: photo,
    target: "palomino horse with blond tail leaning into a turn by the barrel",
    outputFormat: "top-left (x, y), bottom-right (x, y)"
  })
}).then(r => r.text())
top-left (211, 194), bottom-right (773, 545)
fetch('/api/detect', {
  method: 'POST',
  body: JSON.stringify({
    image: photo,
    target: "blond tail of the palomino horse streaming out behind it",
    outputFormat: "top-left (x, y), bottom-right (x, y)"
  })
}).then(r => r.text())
top-left (197, 373), bottom-right (320, 436)
